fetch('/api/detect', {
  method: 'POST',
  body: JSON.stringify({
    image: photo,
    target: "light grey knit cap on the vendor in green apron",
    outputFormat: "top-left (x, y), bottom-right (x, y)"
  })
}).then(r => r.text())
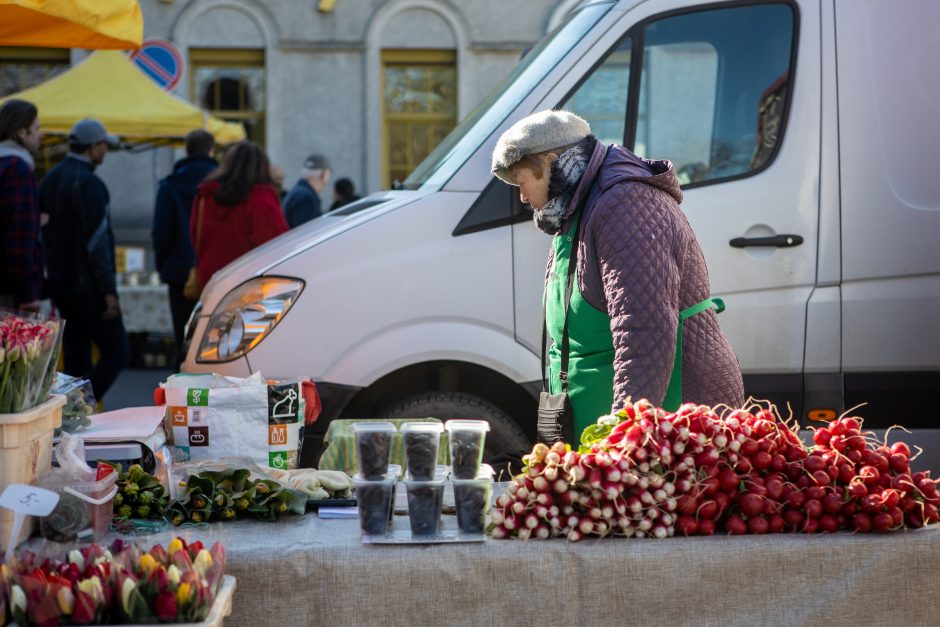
top-left (491, 110), bottom-right (591, 185)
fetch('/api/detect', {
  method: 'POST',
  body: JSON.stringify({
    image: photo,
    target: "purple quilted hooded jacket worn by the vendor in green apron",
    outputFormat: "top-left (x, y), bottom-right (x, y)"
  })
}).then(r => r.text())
top-left (548, 142), bottom-right (744, 411)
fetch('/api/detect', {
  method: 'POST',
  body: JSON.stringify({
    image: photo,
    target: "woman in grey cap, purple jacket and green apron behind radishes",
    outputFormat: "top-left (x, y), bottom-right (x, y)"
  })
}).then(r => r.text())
top-left (492, 111), bottom-right (744, 443)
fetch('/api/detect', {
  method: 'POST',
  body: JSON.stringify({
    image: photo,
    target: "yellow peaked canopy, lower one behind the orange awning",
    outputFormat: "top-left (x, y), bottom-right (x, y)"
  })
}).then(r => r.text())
top-left (0, 51), bottom-right (245, 144)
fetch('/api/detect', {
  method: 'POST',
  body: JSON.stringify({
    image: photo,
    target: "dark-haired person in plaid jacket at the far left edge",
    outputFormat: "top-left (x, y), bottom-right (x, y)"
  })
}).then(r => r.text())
top-left (0, 100), bottom-right (43, 312)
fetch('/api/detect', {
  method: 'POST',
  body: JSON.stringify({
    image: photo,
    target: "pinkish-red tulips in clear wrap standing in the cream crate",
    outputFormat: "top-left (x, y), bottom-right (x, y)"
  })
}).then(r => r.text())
top-left (0, 311), bottom-right (65, 413)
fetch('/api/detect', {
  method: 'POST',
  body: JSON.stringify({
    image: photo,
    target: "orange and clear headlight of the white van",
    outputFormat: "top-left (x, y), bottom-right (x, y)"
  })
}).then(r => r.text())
top-left (196, 277), bottom-right (304, 363)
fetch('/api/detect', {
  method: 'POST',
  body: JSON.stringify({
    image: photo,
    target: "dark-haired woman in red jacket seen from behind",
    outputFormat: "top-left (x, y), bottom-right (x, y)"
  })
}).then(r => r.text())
top-left (189, 141), bottom-right (289, 285)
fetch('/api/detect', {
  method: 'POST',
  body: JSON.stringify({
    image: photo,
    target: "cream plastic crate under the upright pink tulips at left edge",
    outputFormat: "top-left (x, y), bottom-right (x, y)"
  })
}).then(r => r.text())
top-left (0, 394), bottom-right (65, 546)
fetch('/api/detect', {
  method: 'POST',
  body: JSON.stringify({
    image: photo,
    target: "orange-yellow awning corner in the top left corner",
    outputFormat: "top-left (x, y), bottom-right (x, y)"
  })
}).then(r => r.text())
top-left (0, 0), bottom-right (144, 50)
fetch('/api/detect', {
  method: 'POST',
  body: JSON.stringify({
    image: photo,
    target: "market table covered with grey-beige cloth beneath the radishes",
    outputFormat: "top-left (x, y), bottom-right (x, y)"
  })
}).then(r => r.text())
top-left (132, 512), bottom-right (940, 627)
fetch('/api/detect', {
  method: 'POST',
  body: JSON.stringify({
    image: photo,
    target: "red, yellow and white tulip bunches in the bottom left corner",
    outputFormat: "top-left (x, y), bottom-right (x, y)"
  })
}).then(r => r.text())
top-left (0, 538), bottom-right (225, 625)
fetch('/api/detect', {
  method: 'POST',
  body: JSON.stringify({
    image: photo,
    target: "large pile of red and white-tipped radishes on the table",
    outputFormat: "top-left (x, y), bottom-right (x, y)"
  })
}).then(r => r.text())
top-left (490, 400), bottom-right (940, 541)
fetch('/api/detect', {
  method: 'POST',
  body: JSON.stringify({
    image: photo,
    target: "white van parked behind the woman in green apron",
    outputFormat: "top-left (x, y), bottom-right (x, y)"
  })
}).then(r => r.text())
top-left (184, 0), bottom-right (940, 466)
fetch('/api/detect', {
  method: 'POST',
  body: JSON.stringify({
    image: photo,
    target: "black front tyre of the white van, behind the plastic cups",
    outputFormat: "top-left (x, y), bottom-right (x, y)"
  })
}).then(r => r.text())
top-left (379, 392), bottom-right (532, 459)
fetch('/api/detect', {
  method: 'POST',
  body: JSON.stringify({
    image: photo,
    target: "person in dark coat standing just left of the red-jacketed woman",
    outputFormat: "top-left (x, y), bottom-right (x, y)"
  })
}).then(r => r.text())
top-left (152, 130), bottom-right (219, 370)
